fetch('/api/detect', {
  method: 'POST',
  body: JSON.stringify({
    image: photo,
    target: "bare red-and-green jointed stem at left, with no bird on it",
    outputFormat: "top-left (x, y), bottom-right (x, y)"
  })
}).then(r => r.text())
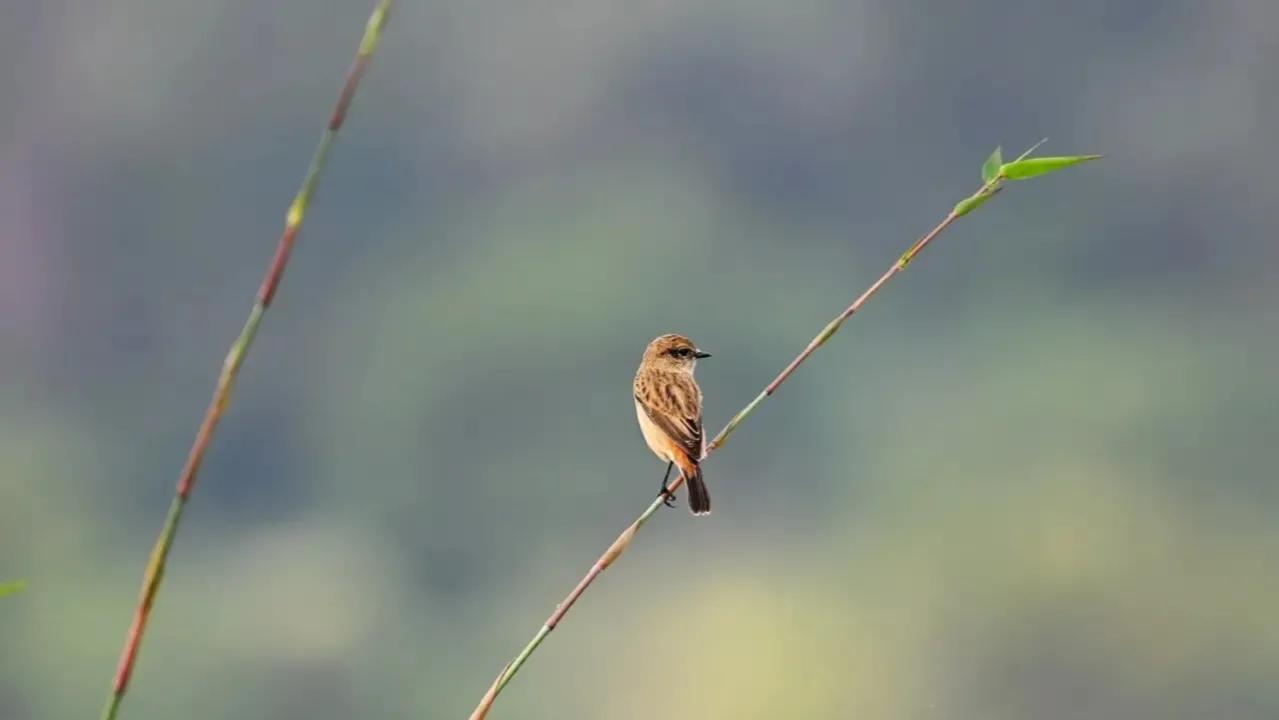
top-left (101, 0), bottom-right (393, 720)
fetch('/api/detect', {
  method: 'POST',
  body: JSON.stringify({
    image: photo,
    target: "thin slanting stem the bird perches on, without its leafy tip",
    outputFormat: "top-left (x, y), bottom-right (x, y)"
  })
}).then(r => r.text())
top-left (471, 176), bottom-right (1003, 720)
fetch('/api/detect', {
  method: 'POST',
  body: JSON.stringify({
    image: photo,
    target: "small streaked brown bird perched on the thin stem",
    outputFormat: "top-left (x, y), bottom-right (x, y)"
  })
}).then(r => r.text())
top-left (634, 334), bottom-right (711, 515)
